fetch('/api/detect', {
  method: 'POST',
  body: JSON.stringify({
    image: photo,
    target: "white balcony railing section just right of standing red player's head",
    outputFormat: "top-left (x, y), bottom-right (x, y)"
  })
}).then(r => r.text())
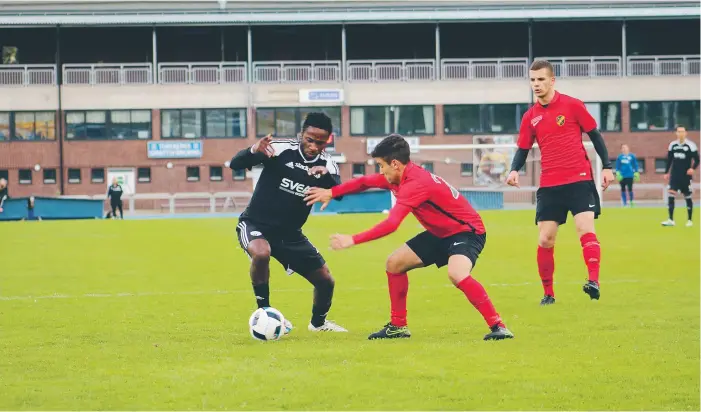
top-left (536, 56), bottom-right (623, 77)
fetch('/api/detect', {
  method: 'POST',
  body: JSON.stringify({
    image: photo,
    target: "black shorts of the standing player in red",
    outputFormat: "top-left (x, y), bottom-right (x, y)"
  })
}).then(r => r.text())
top-left (535, 180), bottom-right (601, 225)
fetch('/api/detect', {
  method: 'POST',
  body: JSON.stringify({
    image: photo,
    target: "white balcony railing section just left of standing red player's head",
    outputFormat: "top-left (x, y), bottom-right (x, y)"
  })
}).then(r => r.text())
top-left (441, 58), bottom-right (528, 80)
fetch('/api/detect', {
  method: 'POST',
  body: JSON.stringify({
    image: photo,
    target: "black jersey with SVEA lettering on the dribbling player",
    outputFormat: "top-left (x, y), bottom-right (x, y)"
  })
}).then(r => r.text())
top-left (229, 140), bottom-right (341, 232)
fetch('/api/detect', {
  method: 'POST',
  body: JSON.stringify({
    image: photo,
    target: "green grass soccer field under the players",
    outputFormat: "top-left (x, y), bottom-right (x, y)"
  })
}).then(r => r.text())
top-left (0, 209), bottom-right (699, 410)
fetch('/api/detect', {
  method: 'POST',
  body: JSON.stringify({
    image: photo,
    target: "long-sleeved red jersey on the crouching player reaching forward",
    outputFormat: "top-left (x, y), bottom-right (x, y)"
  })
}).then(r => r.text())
top-left (331, 162), bottom-right (485, 244)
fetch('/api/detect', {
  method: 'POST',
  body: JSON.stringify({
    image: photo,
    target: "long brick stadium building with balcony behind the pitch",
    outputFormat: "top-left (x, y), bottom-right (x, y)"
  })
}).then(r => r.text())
top-left (0, 0), bottom-right (701, 209)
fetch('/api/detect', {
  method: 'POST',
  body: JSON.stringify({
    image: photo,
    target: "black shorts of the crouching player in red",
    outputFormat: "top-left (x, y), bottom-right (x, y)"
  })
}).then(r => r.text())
top-left (406, 231), bottom-right (487, 267)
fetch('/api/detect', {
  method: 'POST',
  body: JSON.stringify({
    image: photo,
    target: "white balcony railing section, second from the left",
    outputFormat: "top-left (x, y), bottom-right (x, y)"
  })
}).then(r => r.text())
top-left (63, 63), bottom-right (153, 85)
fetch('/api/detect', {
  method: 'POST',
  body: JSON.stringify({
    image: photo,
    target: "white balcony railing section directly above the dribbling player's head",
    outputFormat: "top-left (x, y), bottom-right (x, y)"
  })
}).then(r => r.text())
top-left (253, 60), bottom-right (341, 83)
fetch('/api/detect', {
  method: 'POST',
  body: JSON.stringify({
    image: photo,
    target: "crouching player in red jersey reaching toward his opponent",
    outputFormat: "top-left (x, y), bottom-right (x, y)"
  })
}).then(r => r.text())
top-left (305, 134), bottom-right (514, 340)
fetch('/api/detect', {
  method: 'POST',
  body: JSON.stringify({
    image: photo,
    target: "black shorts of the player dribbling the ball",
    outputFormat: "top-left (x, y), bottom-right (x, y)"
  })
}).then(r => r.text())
top-left (236, 220), bottom-right (326, 276)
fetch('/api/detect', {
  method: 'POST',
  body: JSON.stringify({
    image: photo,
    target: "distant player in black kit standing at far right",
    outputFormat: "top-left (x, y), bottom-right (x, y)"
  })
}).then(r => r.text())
top-left (662, 126), bottom-right (699, 227)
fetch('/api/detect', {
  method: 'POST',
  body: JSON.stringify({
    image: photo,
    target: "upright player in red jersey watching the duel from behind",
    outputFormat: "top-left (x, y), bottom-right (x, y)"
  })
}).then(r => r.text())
top-left (506, 60), bottom-right (613, 305)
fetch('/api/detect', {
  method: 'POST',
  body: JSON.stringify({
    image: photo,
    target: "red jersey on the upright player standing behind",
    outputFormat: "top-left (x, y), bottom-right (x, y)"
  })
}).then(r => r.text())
top-left (518, 92), bottom-right (596, 187)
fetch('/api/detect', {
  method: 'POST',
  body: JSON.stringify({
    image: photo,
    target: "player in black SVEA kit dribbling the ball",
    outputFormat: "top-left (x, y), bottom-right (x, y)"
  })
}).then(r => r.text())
top-left (229, 113), bottom-right (347, 332)
